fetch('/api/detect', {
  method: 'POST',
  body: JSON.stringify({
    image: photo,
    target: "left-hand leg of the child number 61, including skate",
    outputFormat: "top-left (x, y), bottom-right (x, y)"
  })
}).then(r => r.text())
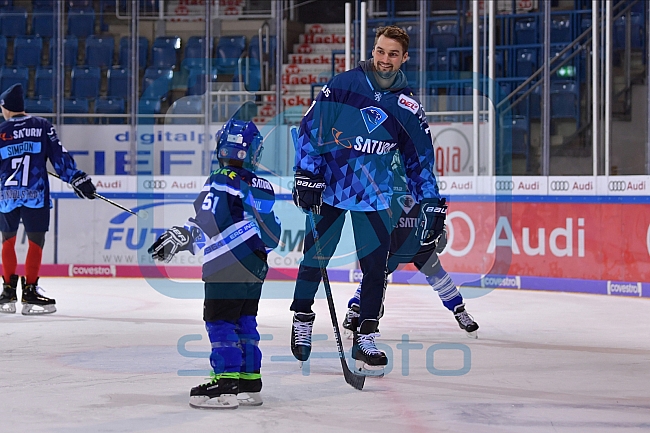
top-left (190, 282), bottom-right (245, 409)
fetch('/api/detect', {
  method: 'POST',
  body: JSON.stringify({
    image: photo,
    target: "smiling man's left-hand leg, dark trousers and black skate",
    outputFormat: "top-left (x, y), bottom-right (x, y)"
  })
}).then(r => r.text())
top-left (289, 204), bottom-right (345, 361)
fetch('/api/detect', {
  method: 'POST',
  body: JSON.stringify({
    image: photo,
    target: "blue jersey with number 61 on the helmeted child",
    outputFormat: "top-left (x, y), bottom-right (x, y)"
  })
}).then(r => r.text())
top-left (185, 166), bottom-right (281, 281)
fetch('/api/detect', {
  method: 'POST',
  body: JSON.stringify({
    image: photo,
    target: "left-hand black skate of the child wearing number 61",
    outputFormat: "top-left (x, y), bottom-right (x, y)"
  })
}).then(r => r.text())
top-left (190, 373), bottom-right (239, 409)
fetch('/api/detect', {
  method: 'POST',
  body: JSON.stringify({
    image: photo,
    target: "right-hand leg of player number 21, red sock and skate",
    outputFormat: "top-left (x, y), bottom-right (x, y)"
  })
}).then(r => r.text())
top-left (20, 207), bottom-right (56, 315)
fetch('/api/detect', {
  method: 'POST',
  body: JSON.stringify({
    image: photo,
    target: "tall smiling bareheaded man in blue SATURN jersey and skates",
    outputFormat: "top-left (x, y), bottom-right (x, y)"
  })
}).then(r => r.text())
top-left (290, 26), bottom-right (446, 374)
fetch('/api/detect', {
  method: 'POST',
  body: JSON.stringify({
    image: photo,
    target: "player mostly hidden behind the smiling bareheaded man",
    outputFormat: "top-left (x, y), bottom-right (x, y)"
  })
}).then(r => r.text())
top-left (343, 155), bottom-right (478, 338)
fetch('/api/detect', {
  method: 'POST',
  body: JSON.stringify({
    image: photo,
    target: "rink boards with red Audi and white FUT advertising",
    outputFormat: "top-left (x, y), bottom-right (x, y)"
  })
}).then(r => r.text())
top-left (6, 176), bottom-right (650, 297)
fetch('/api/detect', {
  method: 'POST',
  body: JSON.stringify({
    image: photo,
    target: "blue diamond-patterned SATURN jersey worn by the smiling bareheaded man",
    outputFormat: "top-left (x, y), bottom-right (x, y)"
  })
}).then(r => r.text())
top-left (294, 61), bottom-right (440, 211)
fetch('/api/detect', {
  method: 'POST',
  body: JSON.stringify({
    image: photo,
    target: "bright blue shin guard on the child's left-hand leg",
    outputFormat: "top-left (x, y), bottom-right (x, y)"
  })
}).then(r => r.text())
top-left (205, 320), bottom-right (242, 374)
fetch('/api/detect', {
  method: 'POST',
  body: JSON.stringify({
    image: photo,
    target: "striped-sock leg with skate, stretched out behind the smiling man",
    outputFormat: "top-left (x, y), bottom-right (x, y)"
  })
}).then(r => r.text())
top-left (413, 252), bottom-right (479, 338)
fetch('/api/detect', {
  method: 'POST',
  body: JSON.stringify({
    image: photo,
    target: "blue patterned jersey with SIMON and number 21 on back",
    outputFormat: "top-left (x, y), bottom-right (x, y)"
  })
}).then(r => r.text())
top-left (0, 116), bottom-right (81, 213)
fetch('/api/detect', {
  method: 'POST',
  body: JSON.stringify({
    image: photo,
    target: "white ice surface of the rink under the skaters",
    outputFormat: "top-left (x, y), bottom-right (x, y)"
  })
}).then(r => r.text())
top-left (0, 278), bottom-right (650, 433)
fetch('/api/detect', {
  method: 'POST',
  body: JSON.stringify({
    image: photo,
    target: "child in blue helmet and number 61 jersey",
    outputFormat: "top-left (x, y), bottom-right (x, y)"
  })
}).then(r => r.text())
top-left (149, 110), bottom-right (280, 409)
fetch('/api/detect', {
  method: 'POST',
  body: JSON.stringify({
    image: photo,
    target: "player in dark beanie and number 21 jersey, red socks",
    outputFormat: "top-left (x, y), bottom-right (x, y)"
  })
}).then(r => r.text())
top-left (0, 84), bottom-right (95, 315)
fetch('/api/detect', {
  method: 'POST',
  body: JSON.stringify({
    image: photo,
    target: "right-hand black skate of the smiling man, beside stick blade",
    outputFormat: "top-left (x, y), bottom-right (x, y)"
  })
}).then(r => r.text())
top-left (352, 319), bottom-right (388, 377)
